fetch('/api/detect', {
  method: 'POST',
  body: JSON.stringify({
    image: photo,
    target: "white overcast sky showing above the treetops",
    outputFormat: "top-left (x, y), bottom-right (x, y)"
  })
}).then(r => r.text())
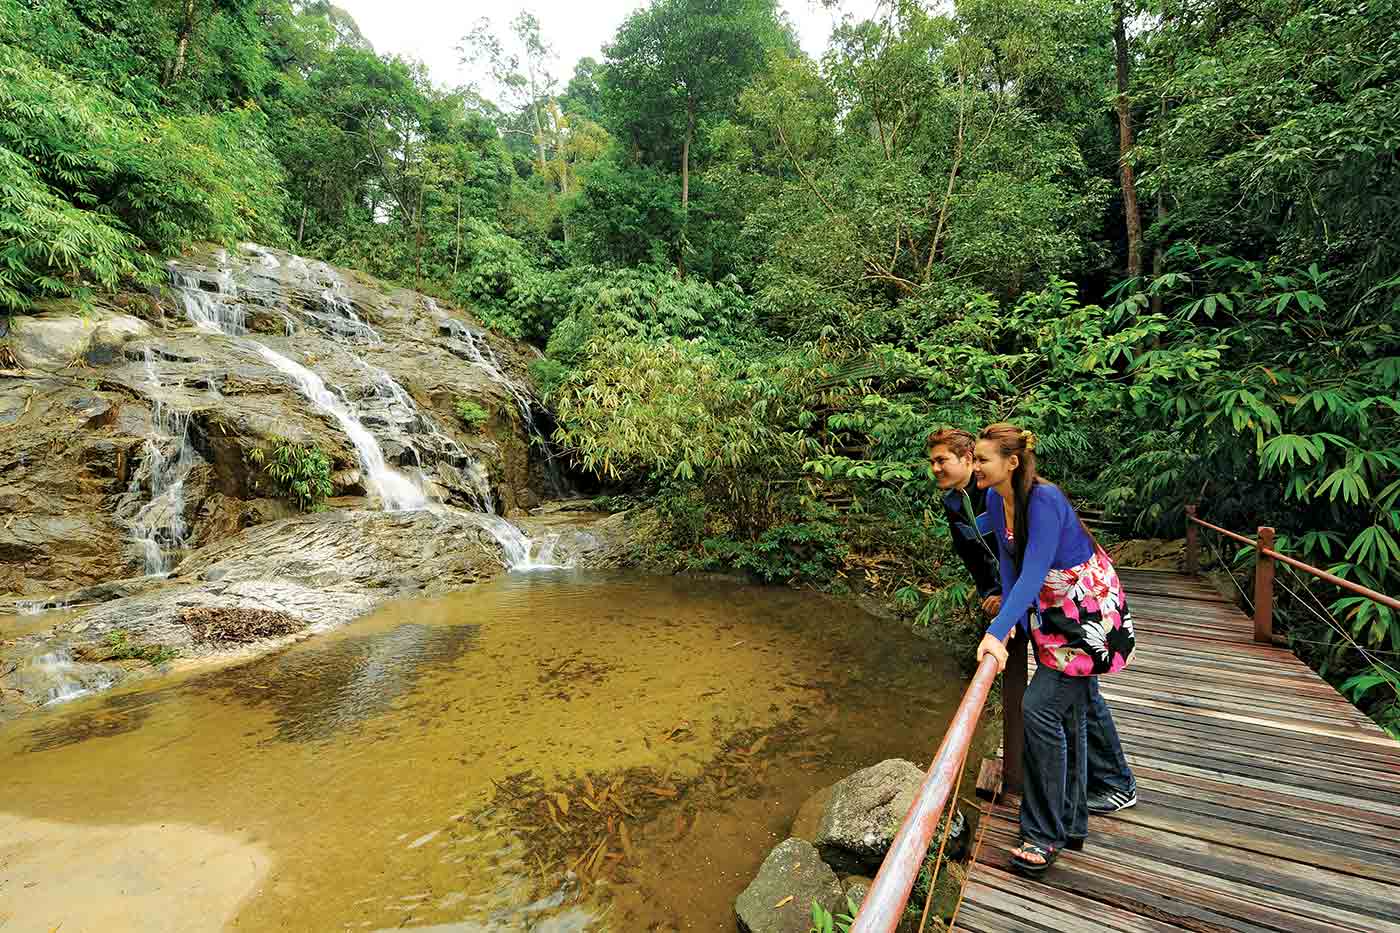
top-left (336, 0), bottom-right (876, 90)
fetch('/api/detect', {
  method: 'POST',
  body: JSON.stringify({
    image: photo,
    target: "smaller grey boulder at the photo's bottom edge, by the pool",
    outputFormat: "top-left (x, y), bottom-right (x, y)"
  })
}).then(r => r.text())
top-left (734, 839), bottom-right (841, 933)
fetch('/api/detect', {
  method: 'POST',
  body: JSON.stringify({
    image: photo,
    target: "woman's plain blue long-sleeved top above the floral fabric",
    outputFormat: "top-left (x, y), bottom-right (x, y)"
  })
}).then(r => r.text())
top-left (987, 483), bottom-right (1093, 639)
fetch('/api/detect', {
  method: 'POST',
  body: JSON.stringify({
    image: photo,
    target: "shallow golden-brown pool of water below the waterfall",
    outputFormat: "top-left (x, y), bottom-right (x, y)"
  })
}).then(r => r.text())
top-left (0, 573), bottom-right (976, 933)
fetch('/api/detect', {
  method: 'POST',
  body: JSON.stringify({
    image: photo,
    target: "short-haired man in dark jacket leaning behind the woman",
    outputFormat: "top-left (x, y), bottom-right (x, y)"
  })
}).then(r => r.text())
top-left (928, 427), bottom-right (1137, 815)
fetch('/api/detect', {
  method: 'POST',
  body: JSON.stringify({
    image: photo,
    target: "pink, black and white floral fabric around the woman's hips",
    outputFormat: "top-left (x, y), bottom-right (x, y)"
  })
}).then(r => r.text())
top-left (1030, 546), bottom-right (1137, 677)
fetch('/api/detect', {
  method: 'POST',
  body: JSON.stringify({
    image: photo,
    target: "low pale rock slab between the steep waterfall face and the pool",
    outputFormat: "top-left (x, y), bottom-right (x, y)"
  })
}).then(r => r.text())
top-left (0, 510), bottom-right (526, 708)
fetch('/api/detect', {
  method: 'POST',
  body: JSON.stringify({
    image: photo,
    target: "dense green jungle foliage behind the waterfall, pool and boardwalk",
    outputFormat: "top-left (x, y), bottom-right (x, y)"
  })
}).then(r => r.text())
top-left (0, 0), bottom-right (1400, 721)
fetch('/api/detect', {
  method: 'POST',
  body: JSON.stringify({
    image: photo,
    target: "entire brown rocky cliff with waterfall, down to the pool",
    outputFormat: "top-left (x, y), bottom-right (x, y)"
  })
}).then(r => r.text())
top-left (0, 244), bottom-right (618, 706)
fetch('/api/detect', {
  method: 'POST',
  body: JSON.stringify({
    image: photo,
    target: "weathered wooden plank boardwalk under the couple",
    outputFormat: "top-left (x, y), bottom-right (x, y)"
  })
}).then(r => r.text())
top-left (956, 570), bottom-right (1400, 933)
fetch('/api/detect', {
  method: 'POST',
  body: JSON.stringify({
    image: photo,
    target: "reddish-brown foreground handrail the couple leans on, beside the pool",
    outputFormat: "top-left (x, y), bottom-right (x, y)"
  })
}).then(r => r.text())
top-left (851, 656), bottom-right (1002, 933)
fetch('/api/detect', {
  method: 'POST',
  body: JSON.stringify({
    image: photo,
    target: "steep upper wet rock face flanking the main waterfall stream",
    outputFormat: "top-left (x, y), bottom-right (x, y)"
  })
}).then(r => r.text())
top-left (0, 245), bottom-right (554, 595)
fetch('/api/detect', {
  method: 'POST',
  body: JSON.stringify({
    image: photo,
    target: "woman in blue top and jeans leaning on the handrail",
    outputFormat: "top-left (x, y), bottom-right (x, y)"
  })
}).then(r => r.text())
top-left (974, 424), bottom-right (1134, 874)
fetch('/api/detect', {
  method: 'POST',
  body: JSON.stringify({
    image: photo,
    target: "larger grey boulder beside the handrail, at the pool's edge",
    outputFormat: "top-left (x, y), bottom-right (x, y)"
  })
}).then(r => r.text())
top-left (812, 758), bottom-right (924, 874)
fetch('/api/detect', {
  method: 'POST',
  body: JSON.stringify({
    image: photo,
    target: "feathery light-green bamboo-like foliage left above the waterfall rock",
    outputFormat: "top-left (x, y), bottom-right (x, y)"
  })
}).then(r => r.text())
top-left (0, 26), bottom-right (283, 310)
